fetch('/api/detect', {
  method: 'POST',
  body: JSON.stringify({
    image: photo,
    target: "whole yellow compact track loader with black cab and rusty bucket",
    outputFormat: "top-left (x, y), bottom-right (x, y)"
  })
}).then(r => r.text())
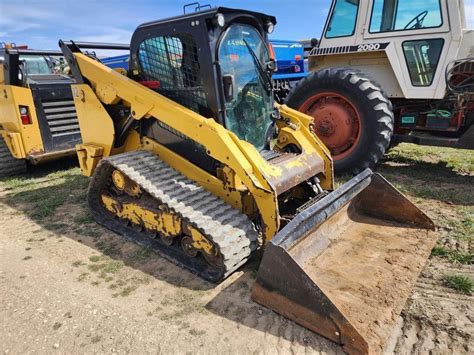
top-left (60, 7), bottom-right (434, 353)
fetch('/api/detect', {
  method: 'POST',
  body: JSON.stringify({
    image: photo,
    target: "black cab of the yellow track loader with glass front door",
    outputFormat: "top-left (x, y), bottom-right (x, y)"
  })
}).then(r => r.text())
top-left (130, 7), bottom-right (276, 152)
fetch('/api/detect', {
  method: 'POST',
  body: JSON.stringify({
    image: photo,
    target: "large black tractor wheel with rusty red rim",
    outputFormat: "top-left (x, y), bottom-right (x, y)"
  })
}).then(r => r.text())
top-left (286, 68), bottom-right (394, 175)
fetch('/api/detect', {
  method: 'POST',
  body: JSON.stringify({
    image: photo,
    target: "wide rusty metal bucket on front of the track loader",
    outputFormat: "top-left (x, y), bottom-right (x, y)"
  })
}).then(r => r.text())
top-left (252, 169), bottom-right (436, 354)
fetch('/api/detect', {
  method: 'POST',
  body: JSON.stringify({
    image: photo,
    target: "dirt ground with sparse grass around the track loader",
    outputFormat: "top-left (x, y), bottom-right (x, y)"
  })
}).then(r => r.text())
top-left (0, 145), bottom-right (474, 354)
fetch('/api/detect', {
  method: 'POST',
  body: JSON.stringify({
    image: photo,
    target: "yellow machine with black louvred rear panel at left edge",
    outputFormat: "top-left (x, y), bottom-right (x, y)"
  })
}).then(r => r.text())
top-left (0, 46), bottom-right (81, 177)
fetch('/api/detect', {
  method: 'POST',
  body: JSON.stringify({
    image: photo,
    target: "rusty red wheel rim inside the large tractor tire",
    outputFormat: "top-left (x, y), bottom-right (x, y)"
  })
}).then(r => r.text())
top-left (299, 92), bottom-right (362, 161)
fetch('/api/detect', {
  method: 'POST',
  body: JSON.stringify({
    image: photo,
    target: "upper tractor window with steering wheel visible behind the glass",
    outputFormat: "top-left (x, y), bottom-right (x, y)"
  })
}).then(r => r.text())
top-left (369, 0), bottom-right (443, 33)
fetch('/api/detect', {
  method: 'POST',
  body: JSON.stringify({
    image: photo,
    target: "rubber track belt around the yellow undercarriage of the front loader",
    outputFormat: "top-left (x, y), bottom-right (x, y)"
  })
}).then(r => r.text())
top-left (89, 151), bottom-right (258, 282)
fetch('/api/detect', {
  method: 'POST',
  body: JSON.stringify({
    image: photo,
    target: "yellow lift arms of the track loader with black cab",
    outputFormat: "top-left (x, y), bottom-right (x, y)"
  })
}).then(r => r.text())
top-left (60, 42), bottom-right (333, 240)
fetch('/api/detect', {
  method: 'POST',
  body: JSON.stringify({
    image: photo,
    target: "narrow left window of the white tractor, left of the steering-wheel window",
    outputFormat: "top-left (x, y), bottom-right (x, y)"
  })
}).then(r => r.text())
top-left (326, 0), bottom-right (359, 38)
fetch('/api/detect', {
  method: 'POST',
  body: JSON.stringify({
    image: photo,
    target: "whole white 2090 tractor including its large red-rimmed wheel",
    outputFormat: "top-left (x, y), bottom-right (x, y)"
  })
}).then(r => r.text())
top-left (286, 0), bottom-right (474, 173)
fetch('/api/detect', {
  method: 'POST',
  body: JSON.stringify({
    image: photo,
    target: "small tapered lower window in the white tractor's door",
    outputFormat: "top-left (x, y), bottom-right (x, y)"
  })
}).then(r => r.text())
top-left (403, 39), bottom-right (444, 86)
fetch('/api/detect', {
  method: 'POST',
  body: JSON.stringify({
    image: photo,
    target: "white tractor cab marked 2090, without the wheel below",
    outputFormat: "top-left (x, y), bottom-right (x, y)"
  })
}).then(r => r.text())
top-left (309, 0), bottom-right (465, 99)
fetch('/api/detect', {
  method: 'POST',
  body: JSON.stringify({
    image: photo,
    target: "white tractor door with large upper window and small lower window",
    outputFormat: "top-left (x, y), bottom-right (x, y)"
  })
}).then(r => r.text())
top-left (362, 0), bottom-right (457, 99)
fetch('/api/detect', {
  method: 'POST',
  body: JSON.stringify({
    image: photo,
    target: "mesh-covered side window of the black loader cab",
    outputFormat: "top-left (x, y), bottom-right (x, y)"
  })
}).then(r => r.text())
top-left (138, 34), bottom-right (210, 117)
